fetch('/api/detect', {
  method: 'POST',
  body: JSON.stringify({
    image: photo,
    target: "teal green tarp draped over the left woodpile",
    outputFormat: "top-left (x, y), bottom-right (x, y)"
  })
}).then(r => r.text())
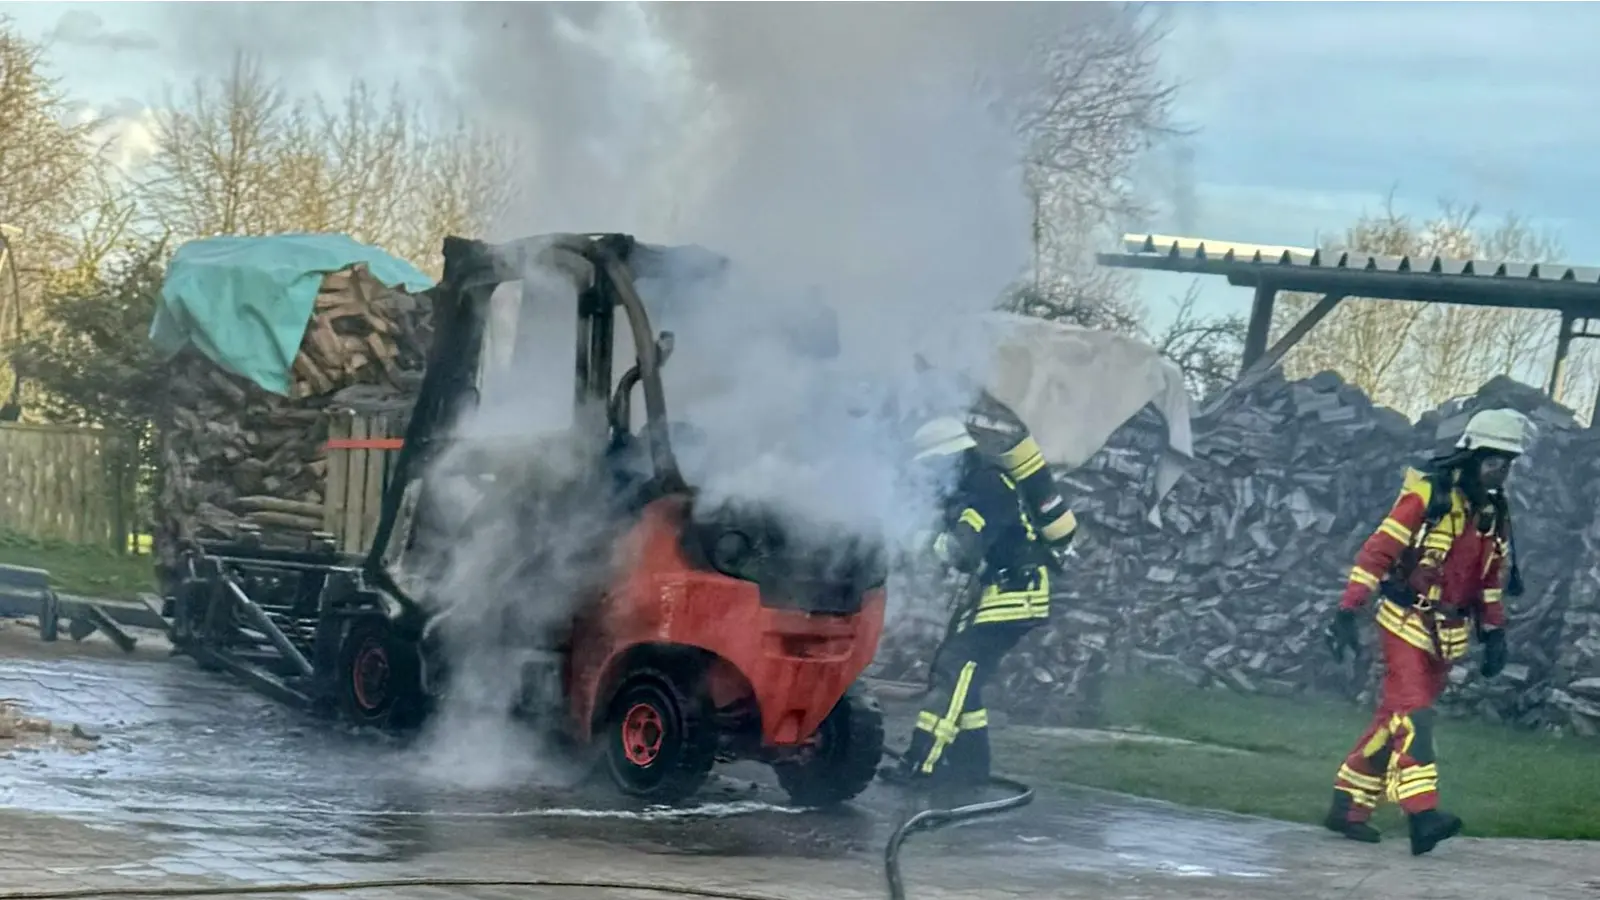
top-left (150, 234), bottom-right (434, 396)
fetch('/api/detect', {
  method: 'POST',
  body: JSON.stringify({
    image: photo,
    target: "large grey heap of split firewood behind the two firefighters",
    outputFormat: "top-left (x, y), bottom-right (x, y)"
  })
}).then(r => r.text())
top-left (878, 372), bottom-right (1600, 733)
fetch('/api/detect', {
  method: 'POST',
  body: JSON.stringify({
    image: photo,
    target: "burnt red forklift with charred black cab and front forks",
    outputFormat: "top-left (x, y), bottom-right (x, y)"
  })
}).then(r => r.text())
top-left (170, 234), bottom-right (886, 806)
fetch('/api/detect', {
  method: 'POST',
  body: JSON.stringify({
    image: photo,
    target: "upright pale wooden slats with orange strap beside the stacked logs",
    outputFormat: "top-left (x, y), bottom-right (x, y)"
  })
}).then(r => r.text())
top-left (323, 412), bottom-right (400, 552)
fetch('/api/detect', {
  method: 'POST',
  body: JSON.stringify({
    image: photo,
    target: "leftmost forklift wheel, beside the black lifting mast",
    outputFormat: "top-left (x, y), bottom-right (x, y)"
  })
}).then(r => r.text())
top-left (336, 618), bottom-right (422, 729)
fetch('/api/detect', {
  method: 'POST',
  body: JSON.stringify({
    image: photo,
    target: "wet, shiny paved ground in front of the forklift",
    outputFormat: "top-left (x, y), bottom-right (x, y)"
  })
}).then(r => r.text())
top-left (0, 624), bottom-right (1600, 897)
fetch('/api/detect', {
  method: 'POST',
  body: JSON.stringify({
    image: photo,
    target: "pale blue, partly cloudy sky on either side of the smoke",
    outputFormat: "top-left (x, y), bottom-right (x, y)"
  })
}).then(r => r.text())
top-left (0, 2), bottom-right (1600, 333)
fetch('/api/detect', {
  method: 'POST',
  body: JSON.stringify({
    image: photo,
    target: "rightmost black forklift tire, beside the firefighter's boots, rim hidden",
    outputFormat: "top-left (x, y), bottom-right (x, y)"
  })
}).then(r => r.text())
top-left (773, 687), bottom-right (883, 807)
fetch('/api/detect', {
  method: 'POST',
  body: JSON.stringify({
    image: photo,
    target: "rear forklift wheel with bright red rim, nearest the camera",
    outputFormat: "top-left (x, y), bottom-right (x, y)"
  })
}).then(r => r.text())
top-left (602, 669), bottom-right (717, 804)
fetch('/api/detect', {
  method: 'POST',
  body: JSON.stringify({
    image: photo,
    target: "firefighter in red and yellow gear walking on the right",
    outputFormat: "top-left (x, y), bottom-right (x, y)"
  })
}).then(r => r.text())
top-left (1326, 410), bottom-right (1526, 855)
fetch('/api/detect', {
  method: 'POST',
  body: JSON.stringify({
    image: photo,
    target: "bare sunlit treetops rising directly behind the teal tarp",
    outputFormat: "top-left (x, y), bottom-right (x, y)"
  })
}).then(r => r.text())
top-left (144, 54), bottom-right (512, 274)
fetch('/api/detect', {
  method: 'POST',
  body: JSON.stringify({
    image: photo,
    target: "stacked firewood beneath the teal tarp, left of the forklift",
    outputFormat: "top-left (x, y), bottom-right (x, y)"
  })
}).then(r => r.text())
top-left (155, 264), bottom-right (432, 564)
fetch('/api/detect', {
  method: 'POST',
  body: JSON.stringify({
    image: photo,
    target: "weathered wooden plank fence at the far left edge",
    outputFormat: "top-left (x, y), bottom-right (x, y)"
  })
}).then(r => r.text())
top-left (0, 424), bottom-right (134, 552)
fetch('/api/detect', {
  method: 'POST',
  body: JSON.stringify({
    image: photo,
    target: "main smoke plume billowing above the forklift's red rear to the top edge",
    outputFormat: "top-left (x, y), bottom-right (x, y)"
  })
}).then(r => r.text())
top-left (459, 5), bottom-right (1035, 547)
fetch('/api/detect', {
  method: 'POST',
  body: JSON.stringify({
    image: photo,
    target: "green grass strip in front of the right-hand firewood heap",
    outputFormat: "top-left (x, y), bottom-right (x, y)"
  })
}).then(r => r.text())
top-left (995, 679), bottom-right (1600, 839)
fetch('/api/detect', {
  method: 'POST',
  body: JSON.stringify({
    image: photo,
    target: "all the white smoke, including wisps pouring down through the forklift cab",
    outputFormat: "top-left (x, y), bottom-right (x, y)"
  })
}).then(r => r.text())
top-left (159, 3), bottom-right (1083, 781)
